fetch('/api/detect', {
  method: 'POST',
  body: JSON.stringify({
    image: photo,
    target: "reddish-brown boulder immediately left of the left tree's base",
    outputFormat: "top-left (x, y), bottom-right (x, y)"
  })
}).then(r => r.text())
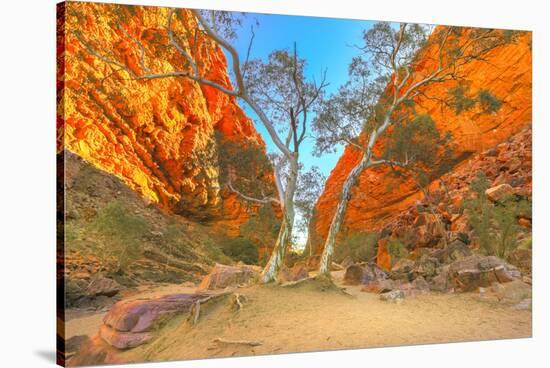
top-left (197, 263), bottom-right (261, 291)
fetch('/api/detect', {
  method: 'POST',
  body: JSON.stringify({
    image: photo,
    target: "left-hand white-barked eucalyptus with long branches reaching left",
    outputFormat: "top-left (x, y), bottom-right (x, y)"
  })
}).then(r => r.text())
top-left (75, 7), bottom-right (327, 282)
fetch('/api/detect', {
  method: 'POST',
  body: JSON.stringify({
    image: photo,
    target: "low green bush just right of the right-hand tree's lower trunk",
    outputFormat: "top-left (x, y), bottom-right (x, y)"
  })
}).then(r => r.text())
top-left (334, 233), bottom-right (378, 262)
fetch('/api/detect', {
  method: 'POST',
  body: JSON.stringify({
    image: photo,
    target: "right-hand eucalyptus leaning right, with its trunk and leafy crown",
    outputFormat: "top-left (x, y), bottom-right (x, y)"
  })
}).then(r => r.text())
top-left (314, 22), bottom-right (515, 273)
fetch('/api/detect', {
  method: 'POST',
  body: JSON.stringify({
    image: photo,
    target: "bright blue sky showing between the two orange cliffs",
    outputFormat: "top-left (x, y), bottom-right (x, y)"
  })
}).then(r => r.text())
top-left (227, 13), bottom-right (373, 176)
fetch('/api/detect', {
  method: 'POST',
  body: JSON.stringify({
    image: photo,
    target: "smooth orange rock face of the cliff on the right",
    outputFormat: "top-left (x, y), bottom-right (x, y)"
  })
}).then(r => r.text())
top-left (312, 28), bottom-right (532, 254)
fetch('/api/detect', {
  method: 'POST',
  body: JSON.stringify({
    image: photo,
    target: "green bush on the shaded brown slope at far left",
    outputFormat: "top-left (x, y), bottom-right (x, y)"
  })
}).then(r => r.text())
top-left (91, 201), bottom-right (150, 272)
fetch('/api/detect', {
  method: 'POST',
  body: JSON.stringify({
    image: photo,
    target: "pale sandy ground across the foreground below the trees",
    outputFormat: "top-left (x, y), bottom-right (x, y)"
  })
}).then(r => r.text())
top-left (60, 275), bottom-right (531, 362)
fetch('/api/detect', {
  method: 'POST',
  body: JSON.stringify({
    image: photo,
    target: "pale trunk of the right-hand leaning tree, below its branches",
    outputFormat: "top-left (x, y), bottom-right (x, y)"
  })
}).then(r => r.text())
top-left (319, 153), bottom-right (370, 274)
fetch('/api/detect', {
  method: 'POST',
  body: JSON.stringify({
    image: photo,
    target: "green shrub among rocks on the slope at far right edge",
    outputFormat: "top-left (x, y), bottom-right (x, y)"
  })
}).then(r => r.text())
top-left (464, 172), bottom-right (531, 258)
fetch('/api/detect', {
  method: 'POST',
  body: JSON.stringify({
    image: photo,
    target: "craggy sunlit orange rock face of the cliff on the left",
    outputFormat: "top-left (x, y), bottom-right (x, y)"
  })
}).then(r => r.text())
top-left (57, 2), bottom-right (270, 233)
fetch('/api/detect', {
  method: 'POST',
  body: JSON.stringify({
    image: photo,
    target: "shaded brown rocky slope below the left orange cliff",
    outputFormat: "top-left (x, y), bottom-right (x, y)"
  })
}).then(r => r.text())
top-left (58, 152), bottom-right (230, 307)
